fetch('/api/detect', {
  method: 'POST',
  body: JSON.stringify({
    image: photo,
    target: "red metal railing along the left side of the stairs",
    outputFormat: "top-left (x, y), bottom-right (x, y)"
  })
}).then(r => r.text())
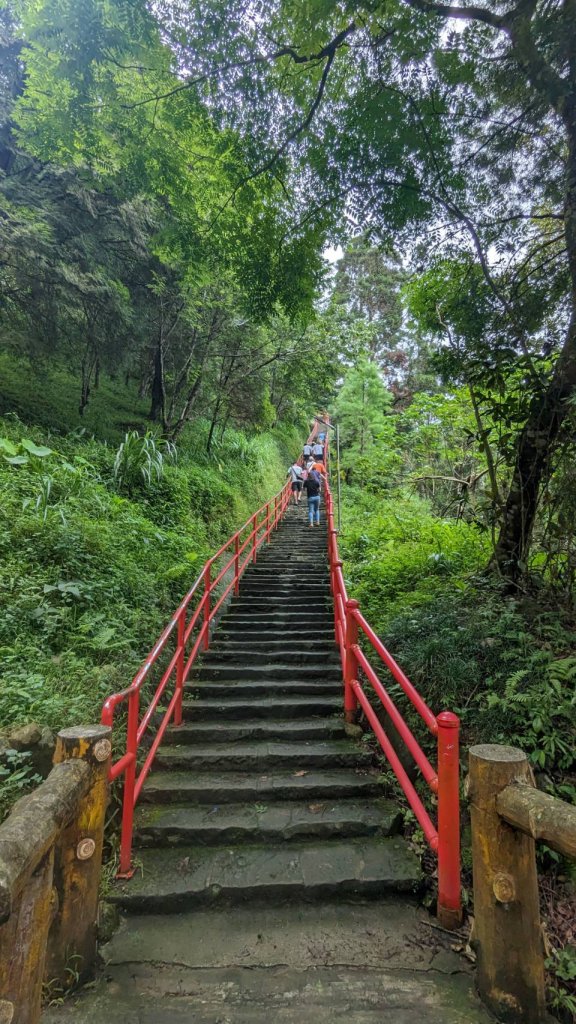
top-left (101, 483), bottom-right (290, 878)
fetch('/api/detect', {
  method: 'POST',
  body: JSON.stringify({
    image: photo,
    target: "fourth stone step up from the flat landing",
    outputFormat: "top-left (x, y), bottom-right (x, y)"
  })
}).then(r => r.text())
top-left (155, 739), bottom-right (372, 772)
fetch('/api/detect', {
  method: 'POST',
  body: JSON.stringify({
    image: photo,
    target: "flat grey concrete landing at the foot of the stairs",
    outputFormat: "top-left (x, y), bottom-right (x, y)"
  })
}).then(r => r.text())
top-left (43, 898), bottom-right (494, 1024)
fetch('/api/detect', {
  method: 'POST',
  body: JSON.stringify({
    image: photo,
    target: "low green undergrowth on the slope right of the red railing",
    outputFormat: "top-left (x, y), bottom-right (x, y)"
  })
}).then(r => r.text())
top-left (342, 483), bottom-right (576, 787)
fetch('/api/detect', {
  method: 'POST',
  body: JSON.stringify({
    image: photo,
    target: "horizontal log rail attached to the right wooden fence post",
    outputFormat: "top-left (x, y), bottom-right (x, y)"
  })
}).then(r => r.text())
top-left (496, 782), bottom-right (576, 858)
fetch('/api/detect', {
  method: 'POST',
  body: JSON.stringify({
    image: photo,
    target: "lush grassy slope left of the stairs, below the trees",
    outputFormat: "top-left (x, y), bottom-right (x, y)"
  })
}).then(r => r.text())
top-left (0, 356), bottom-right (299, 727)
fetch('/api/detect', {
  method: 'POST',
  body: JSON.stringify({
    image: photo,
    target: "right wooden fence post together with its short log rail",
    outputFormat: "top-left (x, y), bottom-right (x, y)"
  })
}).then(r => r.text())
top-left (468, 743), bottom-right (576, 1024)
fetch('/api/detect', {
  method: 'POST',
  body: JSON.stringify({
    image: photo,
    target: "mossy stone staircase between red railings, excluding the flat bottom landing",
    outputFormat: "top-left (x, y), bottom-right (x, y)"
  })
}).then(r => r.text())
top-left (112, 504), bottom-right (419, 912)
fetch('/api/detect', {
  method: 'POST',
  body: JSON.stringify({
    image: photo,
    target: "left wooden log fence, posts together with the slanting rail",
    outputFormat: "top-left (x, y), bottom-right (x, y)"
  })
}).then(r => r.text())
top-left (0, 725), bottom-right (112, 1024)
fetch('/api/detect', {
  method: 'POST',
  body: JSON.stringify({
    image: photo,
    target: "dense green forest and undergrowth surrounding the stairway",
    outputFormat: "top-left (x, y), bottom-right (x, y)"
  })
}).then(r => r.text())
top-left (0, 0), bottom-right (576, 1019)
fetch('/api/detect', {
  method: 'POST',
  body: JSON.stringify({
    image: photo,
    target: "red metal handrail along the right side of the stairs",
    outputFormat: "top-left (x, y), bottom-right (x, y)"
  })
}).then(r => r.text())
top-left (319, 424), bottom-right (461, 928)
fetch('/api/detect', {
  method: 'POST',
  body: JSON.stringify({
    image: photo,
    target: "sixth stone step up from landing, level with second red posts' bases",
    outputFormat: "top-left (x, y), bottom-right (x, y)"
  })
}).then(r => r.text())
top-left (182, 696), bottom-right (342, 725)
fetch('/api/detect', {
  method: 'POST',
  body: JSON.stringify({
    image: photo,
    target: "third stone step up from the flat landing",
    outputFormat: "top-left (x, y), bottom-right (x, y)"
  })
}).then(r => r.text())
top-left (140, 769), bottom-right (382, 806)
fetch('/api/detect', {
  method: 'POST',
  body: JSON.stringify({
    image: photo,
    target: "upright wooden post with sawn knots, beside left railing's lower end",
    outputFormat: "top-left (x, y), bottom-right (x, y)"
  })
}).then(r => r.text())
top-left (45, 725), bottom-right (112, 989)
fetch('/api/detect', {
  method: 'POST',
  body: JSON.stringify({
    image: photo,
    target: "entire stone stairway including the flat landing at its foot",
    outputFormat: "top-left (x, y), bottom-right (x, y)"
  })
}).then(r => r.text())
top-left (45, 505), bottom-right (491, 1024)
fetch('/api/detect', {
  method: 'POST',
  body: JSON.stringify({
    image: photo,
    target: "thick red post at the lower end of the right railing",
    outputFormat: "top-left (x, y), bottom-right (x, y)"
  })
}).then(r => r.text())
top-left (437, 711), bottom-right (462, 929)
